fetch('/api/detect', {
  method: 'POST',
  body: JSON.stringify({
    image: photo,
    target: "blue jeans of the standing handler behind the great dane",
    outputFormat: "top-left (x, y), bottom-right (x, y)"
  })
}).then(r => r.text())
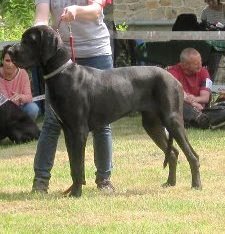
top-left (34, 55), bottom-right (113, 180)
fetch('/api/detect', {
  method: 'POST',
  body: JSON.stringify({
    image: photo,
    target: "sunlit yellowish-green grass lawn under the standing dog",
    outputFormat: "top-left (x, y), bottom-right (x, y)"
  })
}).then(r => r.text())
top-left (0, 116), bottom-right (225, 234)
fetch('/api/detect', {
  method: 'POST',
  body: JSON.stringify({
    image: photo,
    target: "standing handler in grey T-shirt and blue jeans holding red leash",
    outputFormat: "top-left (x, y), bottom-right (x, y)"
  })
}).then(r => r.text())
top-left (32, 0), bottom-right (114, 193)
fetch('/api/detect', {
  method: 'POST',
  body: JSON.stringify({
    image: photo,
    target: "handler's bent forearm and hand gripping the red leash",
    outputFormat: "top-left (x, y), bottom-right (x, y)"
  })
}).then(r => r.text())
top-left (61, 0), bottom-right (105, 22)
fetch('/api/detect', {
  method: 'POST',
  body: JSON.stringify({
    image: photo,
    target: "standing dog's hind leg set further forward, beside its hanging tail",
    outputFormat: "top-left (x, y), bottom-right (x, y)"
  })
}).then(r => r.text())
top-left (142, 112), bottom-right (178, 187)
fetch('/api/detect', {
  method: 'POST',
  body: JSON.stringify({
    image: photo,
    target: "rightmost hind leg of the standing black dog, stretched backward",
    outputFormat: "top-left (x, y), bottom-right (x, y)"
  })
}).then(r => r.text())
top-left (165, 113), bottom-right (201, 189)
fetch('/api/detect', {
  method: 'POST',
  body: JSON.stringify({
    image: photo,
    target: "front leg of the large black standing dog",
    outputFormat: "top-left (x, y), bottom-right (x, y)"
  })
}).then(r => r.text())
top-left (64, 127), bottom-right (88, 197)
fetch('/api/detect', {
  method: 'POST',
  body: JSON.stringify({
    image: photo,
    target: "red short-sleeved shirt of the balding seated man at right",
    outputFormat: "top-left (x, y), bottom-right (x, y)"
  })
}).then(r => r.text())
top-left (168, 64), bottom-right (210, 96)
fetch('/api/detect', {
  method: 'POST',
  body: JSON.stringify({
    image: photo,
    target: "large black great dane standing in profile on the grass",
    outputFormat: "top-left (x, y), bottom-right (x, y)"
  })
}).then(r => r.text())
top-left (9, 26), bottom-right (201, 197)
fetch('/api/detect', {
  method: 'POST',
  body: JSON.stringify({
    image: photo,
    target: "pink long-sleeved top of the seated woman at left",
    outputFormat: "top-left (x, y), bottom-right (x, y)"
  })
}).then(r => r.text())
top-left (0, 68), bottom-right (32, 104)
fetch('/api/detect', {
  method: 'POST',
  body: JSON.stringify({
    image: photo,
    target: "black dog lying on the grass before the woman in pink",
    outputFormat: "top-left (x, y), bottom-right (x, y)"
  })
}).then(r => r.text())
top-left (0, 96), bottom-right (40, 144)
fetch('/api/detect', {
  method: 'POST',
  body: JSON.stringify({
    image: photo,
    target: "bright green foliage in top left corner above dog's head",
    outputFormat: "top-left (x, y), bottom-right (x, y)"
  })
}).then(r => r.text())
top-left (0, 0), bottom-right (34, 41)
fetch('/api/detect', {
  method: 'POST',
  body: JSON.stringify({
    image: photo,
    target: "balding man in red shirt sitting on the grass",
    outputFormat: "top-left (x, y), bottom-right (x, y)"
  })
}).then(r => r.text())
top-left (168, 48), bottom-right (212, 129)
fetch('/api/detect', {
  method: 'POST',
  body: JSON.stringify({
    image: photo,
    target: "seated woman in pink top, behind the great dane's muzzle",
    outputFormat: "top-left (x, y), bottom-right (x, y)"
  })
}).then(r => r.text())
top-left (0, 45), bottom-right (39, 120)
